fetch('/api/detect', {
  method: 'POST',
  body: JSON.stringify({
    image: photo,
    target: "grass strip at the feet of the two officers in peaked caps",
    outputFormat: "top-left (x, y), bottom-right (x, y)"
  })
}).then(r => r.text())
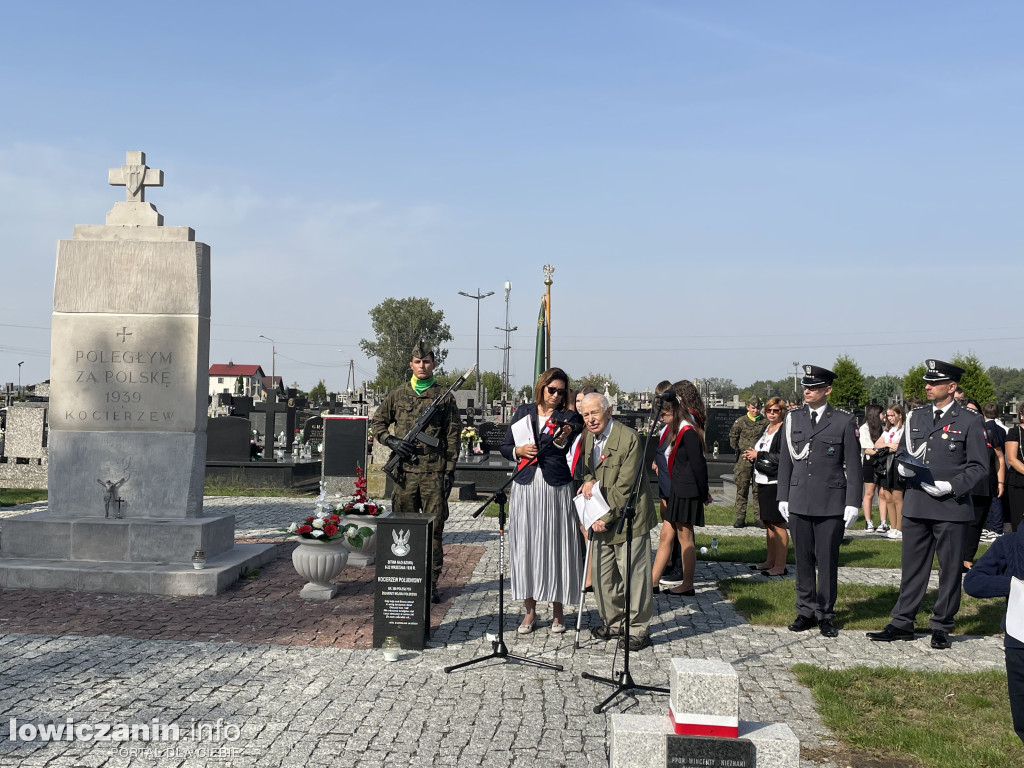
top-left (718, 579), bottom-right (1006, 635)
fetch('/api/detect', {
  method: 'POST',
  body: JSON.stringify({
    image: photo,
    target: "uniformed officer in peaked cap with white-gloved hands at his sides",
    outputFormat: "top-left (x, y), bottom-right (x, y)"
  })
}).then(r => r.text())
top-left (778, 366), bottom-right (863, 637)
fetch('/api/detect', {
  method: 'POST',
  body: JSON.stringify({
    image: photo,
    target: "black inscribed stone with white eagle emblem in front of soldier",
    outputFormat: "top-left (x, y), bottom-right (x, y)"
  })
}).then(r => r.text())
top-left (374, 515), bottom-right (434, 650)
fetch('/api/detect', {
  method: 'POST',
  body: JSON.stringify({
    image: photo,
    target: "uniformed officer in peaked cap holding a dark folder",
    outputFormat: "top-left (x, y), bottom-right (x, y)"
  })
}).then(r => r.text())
top-left (867, 360), bottom-right (988, 650)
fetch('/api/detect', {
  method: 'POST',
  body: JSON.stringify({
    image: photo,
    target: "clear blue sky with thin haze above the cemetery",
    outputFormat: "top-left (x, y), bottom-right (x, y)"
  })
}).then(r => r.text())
top-left (0, 2), bottom-right (1024, 397)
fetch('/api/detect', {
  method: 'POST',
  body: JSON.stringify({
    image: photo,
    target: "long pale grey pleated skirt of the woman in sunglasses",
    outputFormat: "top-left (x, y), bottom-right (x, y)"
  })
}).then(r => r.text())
top-left (508, 470), bottom-right (584, 603)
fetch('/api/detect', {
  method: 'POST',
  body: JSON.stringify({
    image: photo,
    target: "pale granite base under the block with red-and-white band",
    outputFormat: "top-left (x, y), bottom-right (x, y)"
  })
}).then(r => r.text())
top-left (608, 715), bottom-right (800, 768)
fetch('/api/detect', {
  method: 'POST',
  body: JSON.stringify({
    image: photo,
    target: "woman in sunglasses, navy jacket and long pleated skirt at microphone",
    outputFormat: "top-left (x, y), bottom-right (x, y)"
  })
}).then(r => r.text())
top-left (501, 368), bottom-right (583, 635)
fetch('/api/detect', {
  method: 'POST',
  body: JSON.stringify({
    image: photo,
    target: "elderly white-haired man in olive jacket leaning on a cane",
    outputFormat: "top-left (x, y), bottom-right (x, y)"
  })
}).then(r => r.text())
top-left (580, 394), bottom-right (656, 650)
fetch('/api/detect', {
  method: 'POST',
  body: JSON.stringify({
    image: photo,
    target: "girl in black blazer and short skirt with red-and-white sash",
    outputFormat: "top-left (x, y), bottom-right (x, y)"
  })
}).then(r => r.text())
top-left (651, 380), bottom-right (711, 597)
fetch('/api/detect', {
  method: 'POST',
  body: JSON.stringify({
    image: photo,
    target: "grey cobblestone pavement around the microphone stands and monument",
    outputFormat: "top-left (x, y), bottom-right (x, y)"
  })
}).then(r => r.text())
top-left (0, 497), bottom-right (1002, 768)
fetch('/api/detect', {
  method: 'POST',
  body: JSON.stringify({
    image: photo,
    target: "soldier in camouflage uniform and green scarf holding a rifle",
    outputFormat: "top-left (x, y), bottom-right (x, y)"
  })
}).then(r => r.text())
top-left (370, 342), bottom-right (462, 602)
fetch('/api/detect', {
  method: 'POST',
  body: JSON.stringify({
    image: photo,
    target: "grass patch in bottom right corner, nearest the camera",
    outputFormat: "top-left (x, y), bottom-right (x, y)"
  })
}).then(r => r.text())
top-left (793, 667), bottom-right (1024, 768)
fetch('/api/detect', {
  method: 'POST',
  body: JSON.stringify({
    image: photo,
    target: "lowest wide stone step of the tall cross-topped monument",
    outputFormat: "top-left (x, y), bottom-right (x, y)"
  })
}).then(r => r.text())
top-left (0, 544), bottom-right (276, 596)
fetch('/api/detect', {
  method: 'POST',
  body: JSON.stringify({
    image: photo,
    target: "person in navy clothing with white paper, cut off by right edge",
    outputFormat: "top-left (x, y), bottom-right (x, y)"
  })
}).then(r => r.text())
top-left (964, 528), bottom-right (1024, 741)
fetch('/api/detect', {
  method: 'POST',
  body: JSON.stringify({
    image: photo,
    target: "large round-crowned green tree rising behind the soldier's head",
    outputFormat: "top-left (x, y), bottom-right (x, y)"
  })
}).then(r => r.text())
top-left (359, 298), bottom-right (452, 389)
